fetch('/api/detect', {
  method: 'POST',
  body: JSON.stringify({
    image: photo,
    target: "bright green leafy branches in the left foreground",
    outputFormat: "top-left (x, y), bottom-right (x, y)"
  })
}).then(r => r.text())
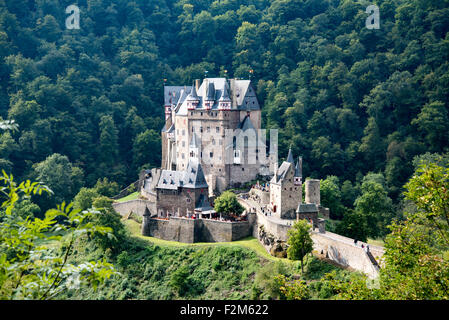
top-left (0, 171), bottom-right (114, 299)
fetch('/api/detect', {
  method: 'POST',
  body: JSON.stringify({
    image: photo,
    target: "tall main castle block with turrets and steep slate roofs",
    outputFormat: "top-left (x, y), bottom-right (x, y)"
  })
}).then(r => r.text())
top-left (162, 78), bottom-right (277, 193)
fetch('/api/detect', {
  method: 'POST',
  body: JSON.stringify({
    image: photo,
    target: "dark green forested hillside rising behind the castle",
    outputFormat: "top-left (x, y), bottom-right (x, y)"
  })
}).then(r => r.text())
top-left (0, 0), bottom-right (449, 228)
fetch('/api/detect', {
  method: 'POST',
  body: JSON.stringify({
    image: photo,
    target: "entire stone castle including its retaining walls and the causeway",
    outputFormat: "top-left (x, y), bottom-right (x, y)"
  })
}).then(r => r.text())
top-left (114, 78), bottom-right (383, 277)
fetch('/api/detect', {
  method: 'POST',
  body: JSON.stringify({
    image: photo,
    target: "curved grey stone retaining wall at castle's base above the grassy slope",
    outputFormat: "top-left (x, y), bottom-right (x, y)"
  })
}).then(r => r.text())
top-left (142, 217), bottom-right (252, 243)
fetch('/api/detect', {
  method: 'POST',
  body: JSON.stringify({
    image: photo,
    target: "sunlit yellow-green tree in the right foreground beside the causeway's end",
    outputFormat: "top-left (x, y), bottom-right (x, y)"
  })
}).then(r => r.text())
top-left (327, 162), bottom-right (449, 300)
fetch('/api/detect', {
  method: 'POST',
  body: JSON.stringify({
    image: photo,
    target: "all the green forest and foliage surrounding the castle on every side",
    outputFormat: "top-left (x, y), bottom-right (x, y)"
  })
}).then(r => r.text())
top-left (0, 0), bottom-right (449, 299)
